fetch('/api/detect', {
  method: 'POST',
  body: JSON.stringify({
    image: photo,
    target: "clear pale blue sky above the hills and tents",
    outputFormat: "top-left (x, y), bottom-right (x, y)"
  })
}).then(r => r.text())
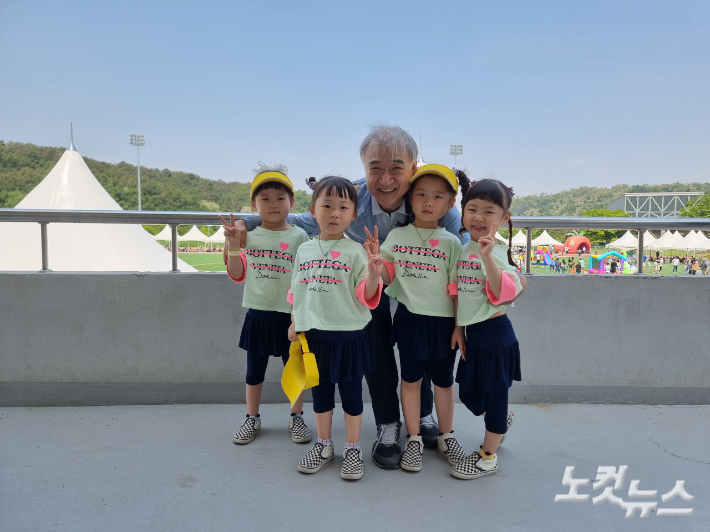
top-left (0, 0), bottom-right (710, 194)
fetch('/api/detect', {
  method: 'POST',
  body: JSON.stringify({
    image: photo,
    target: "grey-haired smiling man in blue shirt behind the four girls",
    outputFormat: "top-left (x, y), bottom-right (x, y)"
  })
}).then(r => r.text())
top-left (237, 125), bottom-right (525, 469)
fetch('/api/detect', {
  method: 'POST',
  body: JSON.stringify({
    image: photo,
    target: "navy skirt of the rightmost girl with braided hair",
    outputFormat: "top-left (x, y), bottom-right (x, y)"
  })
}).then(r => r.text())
top-left (456, 314), bottom-right (521, 392)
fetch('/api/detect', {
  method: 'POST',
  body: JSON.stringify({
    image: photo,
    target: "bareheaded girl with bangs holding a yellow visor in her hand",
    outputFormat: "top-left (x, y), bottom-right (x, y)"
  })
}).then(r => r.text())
top-left (289, 176), bottom-right (383, 480)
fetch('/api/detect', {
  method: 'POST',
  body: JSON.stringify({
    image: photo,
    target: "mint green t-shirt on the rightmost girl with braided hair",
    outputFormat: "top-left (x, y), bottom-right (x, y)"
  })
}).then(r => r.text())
top-left (456, 241), bottom-right (523, 326)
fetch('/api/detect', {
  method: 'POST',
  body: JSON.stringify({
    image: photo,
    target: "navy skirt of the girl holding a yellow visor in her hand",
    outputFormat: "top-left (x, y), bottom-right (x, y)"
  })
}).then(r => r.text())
top-left (305, 329), bottom-right (372, 384)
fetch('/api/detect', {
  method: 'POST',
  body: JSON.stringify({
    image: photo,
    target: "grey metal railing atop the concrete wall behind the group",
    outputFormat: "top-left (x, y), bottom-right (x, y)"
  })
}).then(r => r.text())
top-left (0, 209), bottom-right (710, 273)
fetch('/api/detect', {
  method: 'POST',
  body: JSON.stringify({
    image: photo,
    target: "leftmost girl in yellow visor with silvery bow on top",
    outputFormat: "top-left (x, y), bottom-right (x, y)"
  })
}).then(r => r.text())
top-left (220, 163), bottom-right (311, 444)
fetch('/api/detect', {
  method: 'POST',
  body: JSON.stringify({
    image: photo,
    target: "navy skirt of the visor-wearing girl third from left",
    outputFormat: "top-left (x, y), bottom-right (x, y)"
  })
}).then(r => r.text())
top-left (392, 303), bottom-right (456, 360)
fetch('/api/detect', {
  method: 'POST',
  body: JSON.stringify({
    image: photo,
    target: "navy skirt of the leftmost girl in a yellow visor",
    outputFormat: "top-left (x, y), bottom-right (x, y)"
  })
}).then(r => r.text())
top-left (239, 308), bottom-right (291, 357)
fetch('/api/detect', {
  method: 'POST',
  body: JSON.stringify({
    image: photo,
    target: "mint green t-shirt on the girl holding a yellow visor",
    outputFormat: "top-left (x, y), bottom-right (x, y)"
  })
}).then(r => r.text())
top-left (291, 238), bottom-right (371, 332)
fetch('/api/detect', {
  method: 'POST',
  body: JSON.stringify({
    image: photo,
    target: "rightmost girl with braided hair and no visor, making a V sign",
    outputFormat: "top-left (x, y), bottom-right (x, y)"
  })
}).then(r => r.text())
top-left (451, 179), bottom-right (522, 480)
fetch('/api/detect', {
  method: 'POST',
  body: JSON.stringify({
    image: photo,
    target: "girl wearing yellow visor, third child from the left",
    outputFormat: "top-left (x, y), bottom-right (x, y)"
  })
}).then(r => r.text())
top-left (366, 164), bottom-right (469, 471)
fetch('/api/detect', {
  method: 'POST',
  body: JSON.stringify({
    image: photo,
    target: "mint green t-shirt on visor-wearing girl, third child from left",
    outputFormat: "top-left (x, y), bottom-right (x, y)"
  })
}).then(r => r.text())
top-left (380, 224), bottom-right (461, 317)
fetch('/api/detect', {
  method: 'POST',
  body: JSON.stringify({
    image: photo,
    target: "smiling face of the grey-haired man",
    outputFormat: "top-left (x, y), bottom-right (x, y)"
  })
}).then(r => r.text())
top-left (362, 143), bottom-right (417, 212)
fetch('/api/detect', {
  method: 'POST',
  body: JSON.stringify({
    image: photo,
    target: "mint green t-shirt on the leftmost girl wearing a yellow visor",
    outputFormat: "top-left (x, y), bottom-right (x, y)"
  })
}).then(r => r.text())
top-left (241, 226), bottom-right (308, 314)
